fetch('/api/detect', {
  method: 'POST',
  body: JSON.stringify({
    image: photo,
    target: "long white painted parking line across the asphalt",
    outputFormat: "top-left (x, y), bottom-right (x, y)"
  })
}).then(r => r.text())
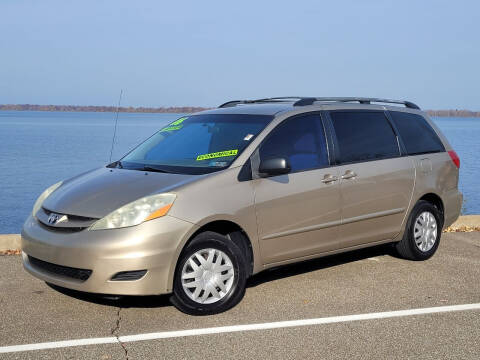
top-left (0, 303), bottom-right (480, 353)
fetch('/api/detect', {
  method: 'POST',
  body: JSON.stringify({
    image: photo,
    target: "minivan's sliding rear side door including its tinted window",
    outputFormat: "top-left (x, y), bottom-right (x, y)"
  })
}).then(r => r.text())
top-left (329, 110), bottom-right (415, 248)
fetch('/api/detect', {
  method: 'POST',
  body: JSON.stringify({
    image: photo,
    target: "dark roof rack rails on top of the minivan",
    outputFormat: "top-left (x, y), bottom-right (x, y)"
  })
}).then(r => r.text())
top-left (219, 96), bottom-right (420, 109)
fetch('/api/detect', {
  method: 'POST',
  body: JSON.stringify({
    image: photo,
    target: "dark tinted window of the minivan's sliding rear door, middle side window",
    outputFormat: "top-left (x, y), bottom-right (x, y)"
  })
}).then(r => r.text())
top-left (330, 111), bottom-right (400, 164)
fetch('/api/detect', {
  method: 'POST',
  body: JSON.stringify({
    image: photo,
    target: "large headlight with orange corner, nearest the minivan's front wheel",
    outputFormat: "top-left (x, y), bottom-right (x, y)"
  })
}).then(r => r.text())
top-left (90, 194), bottom-right (176, 230)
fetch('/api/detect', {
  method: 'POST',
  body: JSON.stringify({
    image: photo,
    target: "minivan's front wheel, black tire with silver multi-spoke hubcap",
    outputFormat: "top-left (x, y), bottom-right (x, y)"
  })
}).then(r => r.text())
top-left (171, 231), bottom-right (247, 315)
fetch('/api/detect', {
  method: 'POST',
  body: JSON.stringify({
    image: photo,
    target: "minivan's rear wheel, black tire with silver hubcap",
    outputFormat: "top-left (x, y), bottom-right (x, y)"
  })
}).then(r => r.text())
top-left (395, 200), bottom-right (443, 261)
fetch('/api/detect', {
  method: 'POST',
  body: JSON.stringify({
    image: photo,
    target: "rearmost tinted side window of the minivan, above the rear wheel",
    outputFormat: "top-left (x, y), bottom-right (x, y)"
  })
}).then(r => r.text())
top-left (390, 111), bottom-right (445, 155)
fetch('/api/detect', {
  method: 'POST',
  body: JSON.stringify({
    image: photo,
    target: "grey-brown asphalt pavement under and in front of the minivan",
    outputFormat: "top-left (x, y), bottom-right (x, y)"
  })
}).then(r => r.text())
top-left (0, 232), bottom-right (480, 359)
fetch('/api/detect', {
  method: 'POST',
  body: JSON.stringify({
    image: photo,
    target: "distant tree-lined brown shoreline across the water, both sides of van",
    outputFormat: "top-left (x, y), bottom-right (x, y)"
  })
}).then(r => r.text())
top-left (0, 104), bottom-right (480, 117)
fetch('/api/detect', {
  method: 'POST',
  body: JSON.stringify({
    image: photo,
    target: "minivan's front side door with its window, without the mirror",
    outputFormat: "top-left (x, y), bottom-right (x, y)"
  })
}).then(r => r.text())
top-left (252, 113), bottom-right (341, 263)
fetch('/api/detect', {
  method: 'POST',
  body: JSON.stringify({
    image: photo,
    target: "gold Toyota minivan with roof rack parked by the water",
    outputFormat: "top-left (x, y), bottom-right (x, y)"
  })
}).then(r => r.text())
top-left (22, 97), bottom-right (462, 314)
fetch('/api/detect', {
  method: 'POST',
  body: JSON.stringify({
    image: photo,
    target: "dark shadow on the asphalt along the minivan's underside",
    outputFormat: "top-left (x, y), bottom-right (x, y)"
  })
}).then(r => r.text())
top-left (47, 244), bottom-right (395, 308)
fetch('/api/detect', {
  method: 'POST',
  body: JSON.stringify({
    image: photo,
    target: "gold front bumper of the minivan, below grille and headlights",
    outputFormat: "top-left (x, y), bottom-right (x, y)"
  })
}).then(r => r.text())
top-left (21, 215), bottom-right (195, 295)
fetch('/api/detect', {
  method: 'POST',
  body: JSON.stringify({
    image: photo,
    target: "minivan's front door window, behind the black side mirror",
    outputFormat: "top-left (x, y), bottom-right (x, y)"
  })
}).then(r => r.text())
top-left (260, 114), bottom-right (329, 172)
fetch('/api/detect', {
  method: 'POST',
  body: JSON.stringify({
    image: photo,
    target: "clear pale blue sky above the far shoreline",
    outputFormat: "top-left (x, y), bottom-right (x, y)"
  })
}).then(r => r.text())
top-left (0, 0), bottom-right (480, 110)
